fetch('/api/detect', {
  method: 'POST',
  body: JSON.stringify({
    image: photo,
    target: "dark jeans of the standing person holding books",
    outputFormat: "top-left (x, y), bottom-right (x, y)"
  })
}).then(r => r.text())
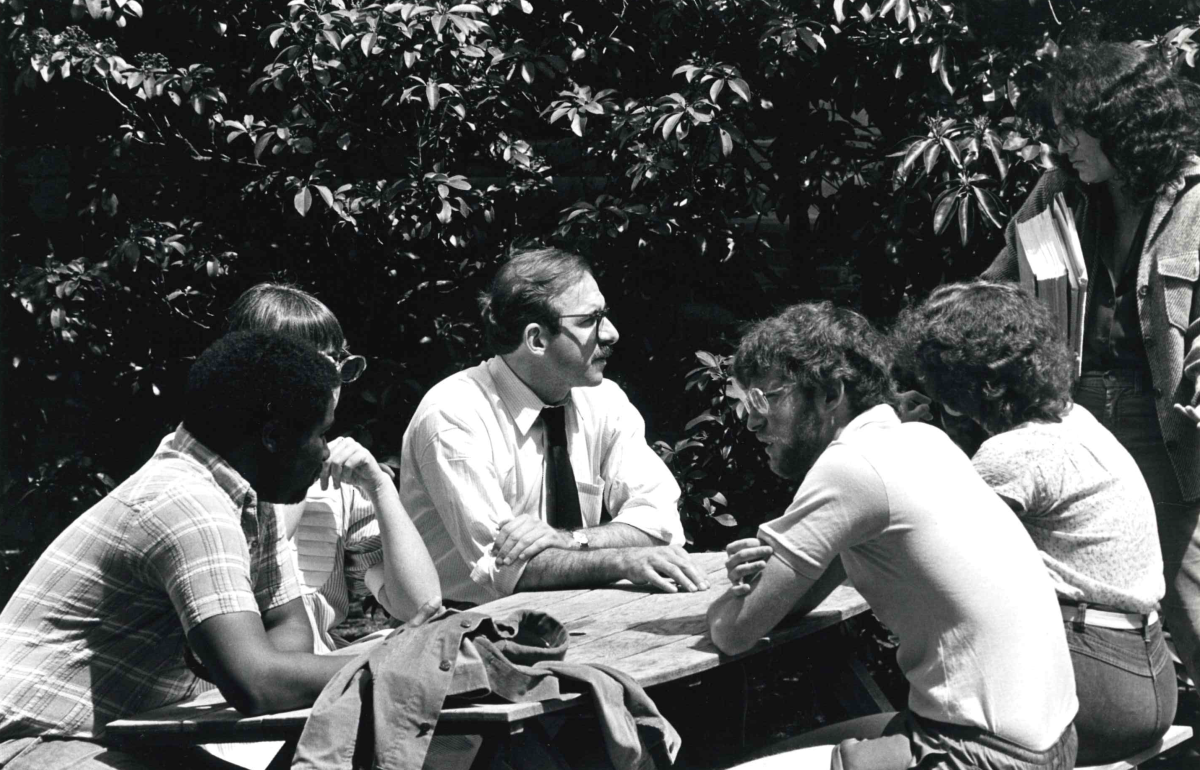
top-left (1075, 369), bottom-right (1200, 681)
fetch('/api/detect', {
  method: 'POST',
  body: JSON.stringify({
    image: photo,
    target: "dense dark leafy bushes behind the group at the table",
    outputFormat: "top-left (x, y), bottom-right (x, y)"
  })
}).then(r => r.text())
top-left (0, 0), bottom-right (1200, 600)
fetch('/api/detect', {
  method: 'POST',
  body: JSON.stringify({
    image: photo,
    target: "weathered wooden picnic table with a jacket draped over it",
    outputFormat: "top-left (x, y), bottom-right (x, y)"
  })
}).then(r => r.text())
top-left (106, 553), bottom-right (874, 745)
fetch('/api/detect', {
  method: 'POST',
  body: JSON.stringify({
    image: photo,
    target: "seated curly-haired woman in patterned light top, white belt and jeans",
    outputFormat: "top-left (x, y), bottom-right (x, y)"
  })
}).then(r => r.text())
top-left (894, 282), bottom-right (1178, 765)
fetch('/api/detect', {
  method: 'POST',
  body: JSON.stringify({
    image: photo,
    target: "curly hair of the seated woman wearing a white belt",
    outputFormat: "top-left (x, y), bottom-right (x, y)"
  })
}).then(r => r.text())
top-left (892, 281), bottom-right (1072, 434)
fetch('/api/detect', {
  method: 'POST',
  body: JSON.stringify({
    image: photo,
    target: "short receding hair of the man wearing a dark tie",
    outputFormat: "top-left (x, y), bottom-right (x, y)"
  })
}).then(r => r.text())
top-left (479, 248), bottom-right (592, 355)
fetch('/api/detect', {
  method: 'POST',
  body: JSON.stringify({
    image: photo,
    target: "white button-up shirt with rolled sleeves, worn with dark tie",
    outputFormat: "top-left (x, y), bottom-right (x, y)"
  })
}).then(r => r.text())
top-left (400, 356), bottom-right (684, 603)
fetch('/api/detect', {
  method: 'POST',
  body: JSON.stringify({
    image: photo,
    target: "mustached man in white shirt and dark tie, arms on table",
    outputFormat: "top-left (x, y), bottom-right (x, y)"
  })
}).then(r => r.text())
top-left (400, 248), bottom-right (708, 603)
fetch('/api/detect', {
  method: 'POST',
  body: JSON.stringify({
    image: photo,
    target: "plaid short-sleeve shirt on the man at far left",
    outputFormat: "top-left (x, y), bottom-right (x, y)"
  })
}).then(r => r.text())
top-left (0, 426), bottom-right (300, 740)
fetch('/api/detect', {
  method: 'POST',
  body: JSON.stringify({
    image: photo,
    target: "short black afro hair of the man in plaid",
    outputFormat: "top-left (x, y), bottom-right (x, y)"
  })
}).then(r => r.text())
top-left (184, 331), bottom-right (341, 455)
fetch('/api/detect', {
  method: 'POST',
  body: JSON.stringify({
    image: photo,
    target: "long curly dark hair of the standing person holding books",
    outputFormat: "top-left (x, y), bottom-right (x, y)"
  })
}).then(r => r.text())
top-left (1034, 42), bottom-right (1200, 200)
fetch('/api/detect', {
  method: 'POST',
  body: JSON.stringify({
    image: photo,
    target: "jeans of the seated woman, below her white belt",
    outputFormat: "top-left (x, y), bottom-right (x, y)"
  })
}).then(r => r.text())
top-left (1063, 621), bottom-right (1178, 765)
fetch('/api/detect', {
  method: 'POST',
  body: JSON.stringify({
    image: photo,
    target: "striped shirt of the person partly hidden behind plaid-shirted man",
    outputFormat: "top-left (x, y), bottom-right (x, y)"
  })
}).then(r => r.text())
top-left (273, 483), bottom-right (383, 652)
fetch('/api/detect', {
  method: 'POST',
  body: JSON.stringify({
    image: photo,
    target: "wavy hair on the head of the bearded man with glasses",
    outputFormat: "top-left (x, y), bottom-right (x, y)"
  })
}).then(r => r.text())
top-left (733, 302), bottom-right (896, 415)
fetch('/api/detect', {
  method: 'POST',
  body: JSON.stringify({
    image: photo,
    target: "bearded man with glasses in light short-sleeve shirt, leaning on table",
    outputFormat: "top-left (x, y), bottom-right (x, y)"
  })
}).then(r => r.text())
top-left (708, 302), bottom-right (1078, 770)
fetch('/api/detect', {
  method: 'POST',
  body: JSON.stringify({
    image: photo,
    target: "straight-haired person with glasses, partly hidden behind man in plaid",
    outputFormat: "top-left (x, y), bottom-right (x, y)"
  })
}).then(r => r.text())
top-left (228, 283), bottom-right (442, 652)
